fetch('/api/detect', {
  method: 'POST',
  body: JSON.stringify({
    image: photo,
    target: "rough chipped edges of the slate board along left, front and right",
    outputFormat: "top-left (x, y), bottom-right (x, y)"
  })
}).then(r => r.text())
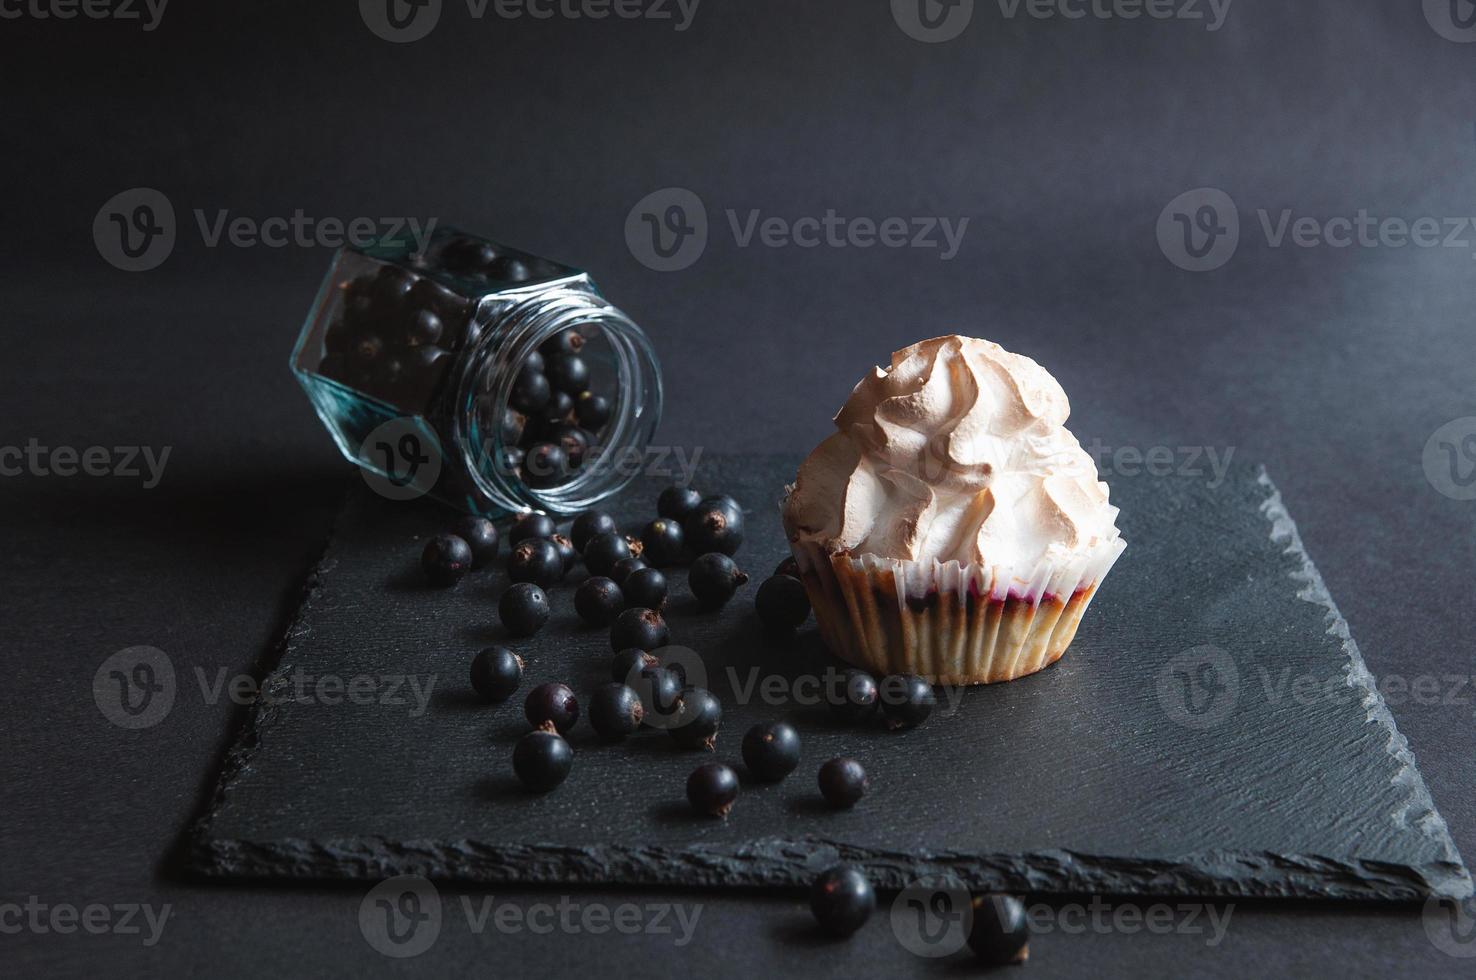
top-left (187, 468), bottom-right (1473, 902)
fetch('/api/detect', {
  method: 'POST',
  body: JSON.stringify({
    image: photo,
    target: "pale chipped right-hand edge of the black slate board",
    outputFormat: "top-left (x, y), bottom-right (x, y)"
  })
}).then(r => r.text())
top-left (1258, 466), bottom-right (1473, 899)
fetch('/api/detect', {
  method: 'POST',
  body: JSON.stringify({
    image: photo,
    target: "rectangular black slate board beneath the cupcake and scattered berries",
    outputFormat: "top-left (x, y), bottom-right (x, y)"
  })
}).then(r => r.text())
top-left (190, 458), bottom-right (1472, 900)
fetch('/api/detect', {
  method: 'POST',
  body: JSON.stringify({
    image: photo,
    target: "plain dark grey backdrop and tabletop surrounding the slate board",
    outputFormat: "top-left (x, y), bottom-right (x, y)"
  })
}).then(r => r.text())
top-left (0, 0), bottom-right (1476, 977)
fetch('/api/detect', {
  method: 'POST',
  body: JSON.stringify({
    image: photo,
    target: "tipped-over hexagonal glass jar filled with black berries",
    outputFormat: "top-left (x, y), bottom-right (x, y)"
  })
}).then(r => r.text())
top-left (292, 229), bottom-right (661, 517)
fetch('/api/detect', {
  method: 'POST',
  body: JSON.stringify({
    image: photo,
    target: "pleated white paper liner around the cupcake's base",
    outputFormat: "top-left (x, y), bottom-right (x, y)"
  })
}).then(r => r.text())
top-left (790, 525), bottom-right (1128, 685)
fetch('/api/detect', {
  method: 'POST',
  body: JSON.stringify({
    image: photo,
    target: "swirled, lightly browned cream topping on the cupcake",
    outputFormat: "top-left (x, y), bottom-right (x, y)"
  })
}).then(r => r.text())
top-left (784, 337), bottom-right (1117, 568)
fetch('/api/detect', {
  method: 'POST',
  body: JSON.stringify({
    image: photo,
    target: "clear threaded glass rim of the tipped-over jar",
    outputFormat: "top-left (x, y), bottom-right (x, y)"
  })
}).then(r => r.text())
top-left (455, 288), bottom-right (661, 515)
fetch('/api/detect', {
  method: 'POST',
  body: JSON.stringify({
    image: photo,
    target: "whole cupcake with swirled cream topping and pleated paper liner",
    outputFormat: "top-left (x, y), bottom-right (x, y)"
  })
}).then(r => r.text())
top-left (782, 337), bottom-right (1126, 683)
